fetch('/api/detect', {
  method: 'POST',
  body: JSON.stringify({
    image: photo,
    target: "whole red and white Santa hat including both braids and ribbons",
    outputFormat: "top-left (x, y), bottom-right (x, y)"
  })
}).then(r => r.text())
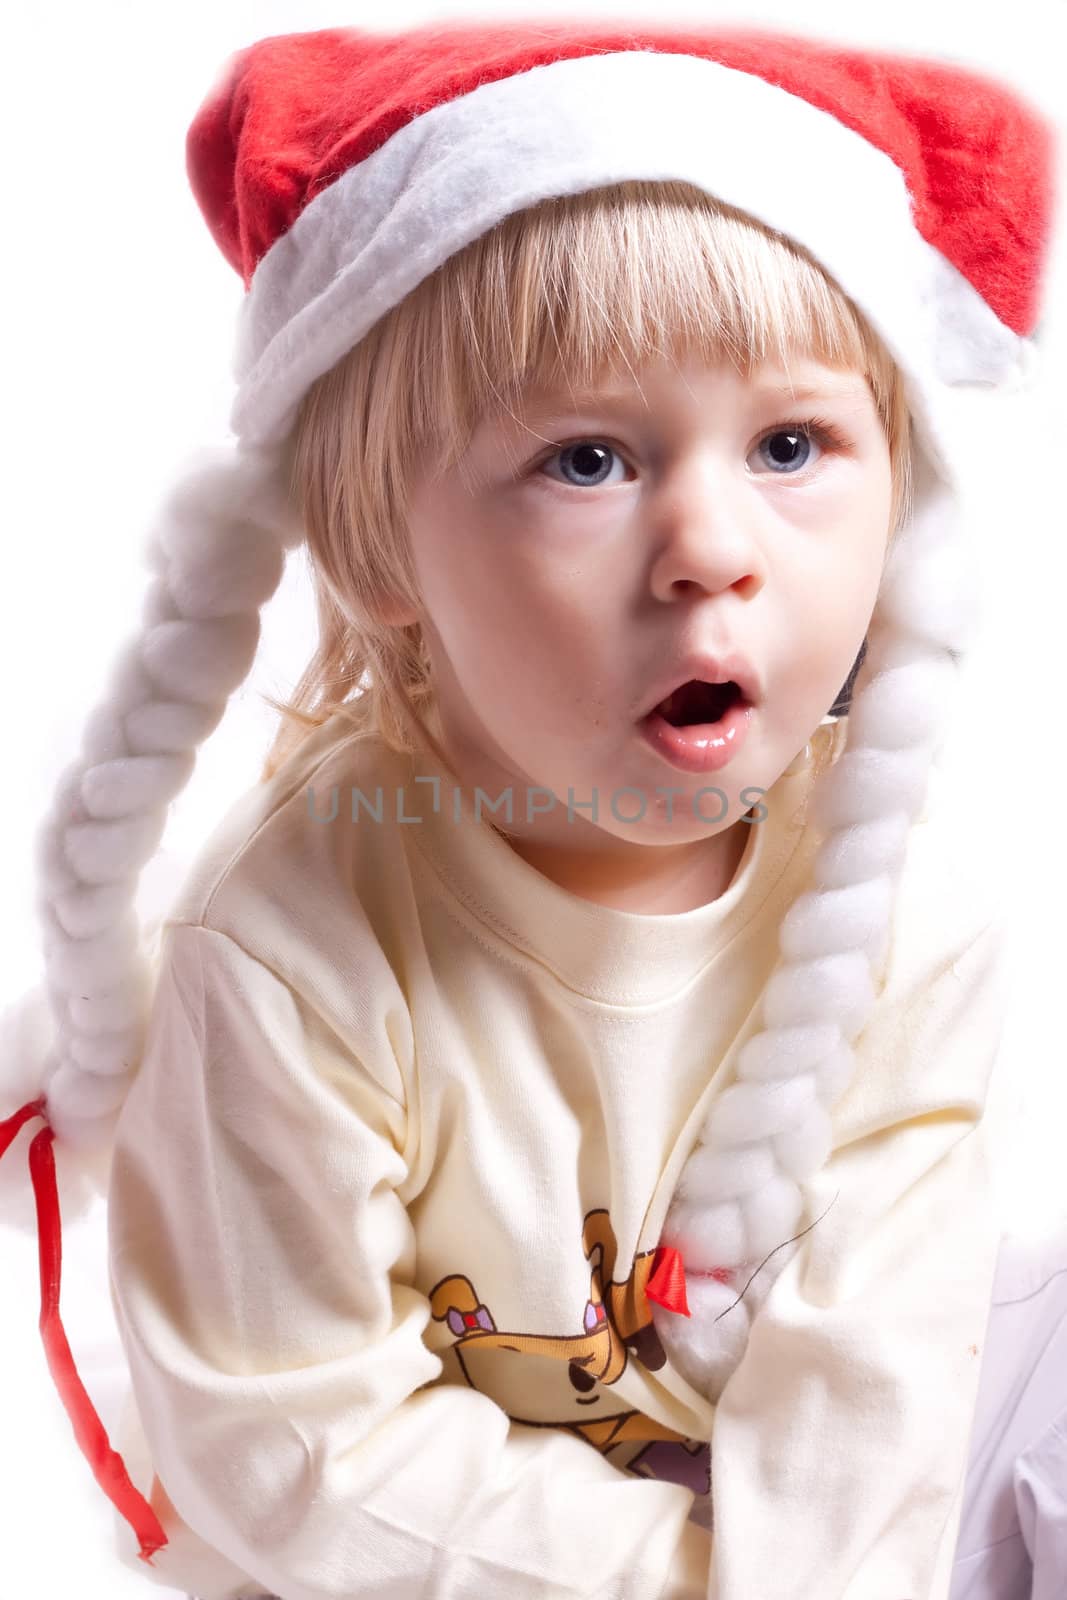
top-left (0, 12), bottom-right (1053, 1560)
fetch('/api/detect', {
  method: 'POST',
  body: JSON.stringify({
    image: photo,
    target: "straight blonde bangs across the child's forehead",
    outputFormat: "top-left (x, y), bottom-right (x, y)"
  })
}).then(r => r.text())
top-left (396, 181), bottom-right (894, 470)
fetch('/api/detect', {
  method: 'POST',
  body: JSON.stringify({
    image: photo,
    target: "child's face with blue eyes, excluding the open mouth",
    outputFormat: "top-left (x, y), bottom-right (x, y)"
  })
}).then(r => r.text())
top-left (397, 360), bottom-right (893, 889)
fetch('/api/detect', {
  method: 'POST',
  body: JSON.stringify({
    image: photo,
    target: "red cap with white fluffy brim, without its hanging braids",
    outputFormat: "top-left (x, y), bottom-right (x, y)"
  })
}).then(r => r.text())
top-left (187, 24), bottom-right (1051, 457)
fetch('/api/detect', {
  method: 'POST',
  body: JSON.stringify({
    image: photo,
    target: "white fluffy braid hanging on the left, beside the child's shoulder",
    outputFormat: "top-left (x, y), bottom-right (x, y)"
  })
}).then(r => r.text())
top-left (21, 443), bottom-right (302, 1163)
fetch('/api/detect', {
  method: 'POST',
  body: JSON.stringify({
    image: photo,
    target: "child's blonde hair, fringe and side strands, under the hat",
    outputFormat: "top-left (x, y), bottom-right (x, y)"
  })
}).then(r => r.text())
top-left (261, 181), bottom-right (912, 779)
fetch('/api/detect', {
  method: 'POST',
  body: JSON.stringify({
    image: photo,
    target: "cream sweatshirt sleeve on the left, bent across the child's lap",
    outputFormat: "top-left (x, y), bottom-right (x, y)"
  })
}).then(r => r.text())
top-left (109, 925), bottom-right (712, 1600)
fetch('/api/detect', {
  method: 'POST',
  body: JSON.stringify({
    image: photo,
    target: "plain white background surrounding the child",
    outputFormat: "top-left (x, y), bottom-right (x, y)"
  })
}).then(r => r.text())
top-left (0, 0), bottom-right (1067, 1600)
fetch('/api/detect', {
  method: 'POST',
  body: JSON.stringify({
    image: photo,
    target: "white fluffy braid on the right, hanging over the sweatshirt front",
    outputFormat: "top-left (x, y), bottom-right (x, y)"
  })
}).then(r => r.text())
top-left (653, 450), bottom-right (977, 1400)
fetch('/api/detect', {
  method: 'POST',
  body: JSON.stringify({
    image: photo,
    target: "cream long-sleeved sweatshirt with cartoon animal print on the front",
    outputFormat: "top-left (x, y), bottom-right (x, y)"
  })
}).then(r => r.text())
top-left (109, 717), bottom-right (1005, 1600)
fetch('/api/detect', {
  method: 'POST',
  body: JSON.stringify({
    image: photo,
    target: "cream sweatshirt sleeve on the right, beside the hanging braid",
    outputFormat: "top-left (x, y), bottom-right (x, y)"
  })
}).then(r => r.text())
top-left (712, 920), bottom-right (1006, 1600)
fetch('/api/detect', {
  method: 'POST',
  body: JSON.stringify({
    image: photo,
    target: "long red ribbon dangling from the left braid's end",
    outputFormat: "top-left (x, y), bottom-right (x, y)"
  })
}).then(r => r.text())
top-left (0, 1094), bottom-right (168, 1566)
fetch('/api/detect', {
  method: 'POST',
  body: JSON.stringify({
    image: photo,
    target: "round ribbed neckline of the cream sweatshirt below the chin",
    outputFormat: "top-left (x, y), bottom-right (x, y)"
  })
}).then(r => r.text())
top-left (388, 722), bottom-right (845, 1005)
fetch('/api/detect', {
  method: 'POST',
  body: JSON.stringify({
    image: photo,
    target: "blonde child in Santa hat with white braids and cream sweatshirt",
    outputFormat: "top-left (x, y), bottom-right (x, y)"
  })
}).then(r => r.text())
top-left (6, 15), bottom-right (1051, 1600)
